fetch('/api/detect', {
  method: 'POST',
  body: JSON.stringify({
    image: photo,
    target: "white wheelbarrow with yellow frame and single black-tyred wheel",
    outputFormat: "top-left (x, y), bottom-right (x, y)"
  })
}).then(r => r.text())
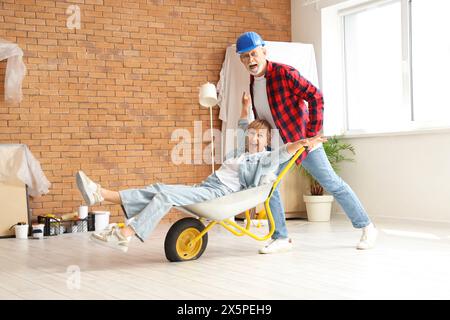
top-left (164, 148), bottom-right (305, 262)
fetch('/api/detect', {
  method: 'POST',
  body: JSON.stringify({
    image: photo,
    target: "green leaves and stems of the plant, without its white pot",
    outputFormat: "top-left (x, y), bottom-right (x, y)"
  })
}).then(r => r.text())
top-left (300, 136), bottom-right (355, 196)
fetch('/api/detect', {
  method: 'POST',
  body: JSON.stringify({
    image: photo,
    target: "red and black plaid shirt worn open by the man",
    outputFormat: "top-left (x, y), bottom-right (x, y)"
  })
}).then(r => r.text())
top-left (250, 61), bottom-right (323, 164)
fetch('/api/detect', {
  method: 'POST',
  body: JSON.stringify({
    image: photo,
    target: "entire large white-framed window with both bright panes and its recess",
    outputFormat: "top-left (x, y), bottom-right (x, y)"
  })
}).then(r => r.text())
top-left (322, 0), bottom-right (450, 134)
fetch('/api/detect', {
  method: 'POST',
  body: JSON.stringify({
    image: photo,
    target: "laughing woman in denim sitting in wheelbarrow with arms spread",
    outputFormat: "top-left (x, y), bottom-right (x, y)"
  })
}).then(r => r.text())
top-left (76, 93), bottom-right (325, 252)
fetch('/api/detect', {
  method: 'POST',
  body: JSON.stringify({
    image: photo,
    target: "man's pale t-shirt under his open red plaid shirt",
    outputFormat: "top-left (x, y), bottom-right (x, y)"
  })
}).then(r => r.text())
top-left (253, 76), bottom-right (322, 152)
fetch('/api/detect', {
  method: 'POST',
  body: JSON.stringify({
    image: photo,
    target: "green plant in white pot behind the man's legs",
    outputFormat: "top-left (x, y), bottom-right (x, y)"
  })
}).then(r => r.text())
top-left (300, 136), bottom-right (355, 221)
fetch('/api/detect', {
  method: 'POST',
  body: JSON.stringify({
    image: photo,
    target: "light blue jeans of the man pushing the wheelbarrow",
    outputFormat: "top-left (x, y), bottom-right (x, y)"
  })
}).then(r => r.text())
top-left (270, 146), bottom-right (370, 239)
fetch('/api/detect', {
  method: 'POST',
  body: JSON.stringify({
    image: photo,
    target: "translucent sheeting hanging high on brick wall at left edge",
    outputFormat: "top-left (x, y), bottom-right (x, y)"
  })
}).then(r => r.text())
top-left (0, 39), bottom-right (27, 103)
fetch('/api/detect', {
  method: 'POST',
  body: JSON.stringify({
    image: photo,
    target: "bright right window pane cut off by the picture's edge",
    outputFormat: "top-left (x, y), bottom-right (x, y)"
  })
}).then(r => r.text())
top-left (411, 0), bottom-right (450, 122)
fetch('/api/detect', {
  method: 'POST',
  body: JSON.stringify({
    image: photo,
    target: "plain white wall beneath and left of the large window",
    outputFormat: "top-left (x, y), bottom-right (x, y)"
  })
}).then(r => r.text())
top-left (291, 0), bottom-right (450, 222)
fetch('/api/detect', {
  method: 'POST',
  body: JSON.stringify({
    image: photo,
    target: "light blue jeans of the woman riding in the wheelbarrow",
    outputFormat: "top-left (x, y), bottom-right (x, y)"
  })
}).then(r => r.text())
top-left (119, 174), bottom-right (233, 241)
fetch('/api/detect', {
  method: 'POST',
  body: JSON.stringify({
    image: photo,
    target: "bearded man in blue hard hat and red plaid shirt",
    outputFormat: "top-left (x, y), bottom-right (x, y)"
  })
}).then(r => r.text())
top-left (236, 32), bottom-right (378, 253)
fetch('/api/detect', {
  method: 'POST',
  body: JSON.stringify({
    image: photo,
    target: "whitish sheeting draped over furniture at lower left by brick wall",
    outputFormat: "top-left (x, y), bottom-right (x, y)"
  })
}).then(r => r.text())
top-left (0, 144), bottom-right (51, 197)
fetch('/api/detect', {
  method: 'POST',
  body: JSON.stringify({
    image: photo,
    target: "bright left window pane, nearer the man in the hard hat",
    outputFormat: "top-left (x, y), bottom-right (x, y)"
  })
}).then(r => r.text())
top-left (343, 1), bottom-right (402, 130)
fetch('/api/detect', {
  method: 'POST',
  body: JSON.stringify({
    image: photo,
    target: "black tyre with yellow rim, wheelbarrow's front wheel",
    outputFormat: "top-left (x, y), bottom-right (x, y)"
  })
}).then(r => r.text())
top-left (164, 218), bottom-right (208, 262)
